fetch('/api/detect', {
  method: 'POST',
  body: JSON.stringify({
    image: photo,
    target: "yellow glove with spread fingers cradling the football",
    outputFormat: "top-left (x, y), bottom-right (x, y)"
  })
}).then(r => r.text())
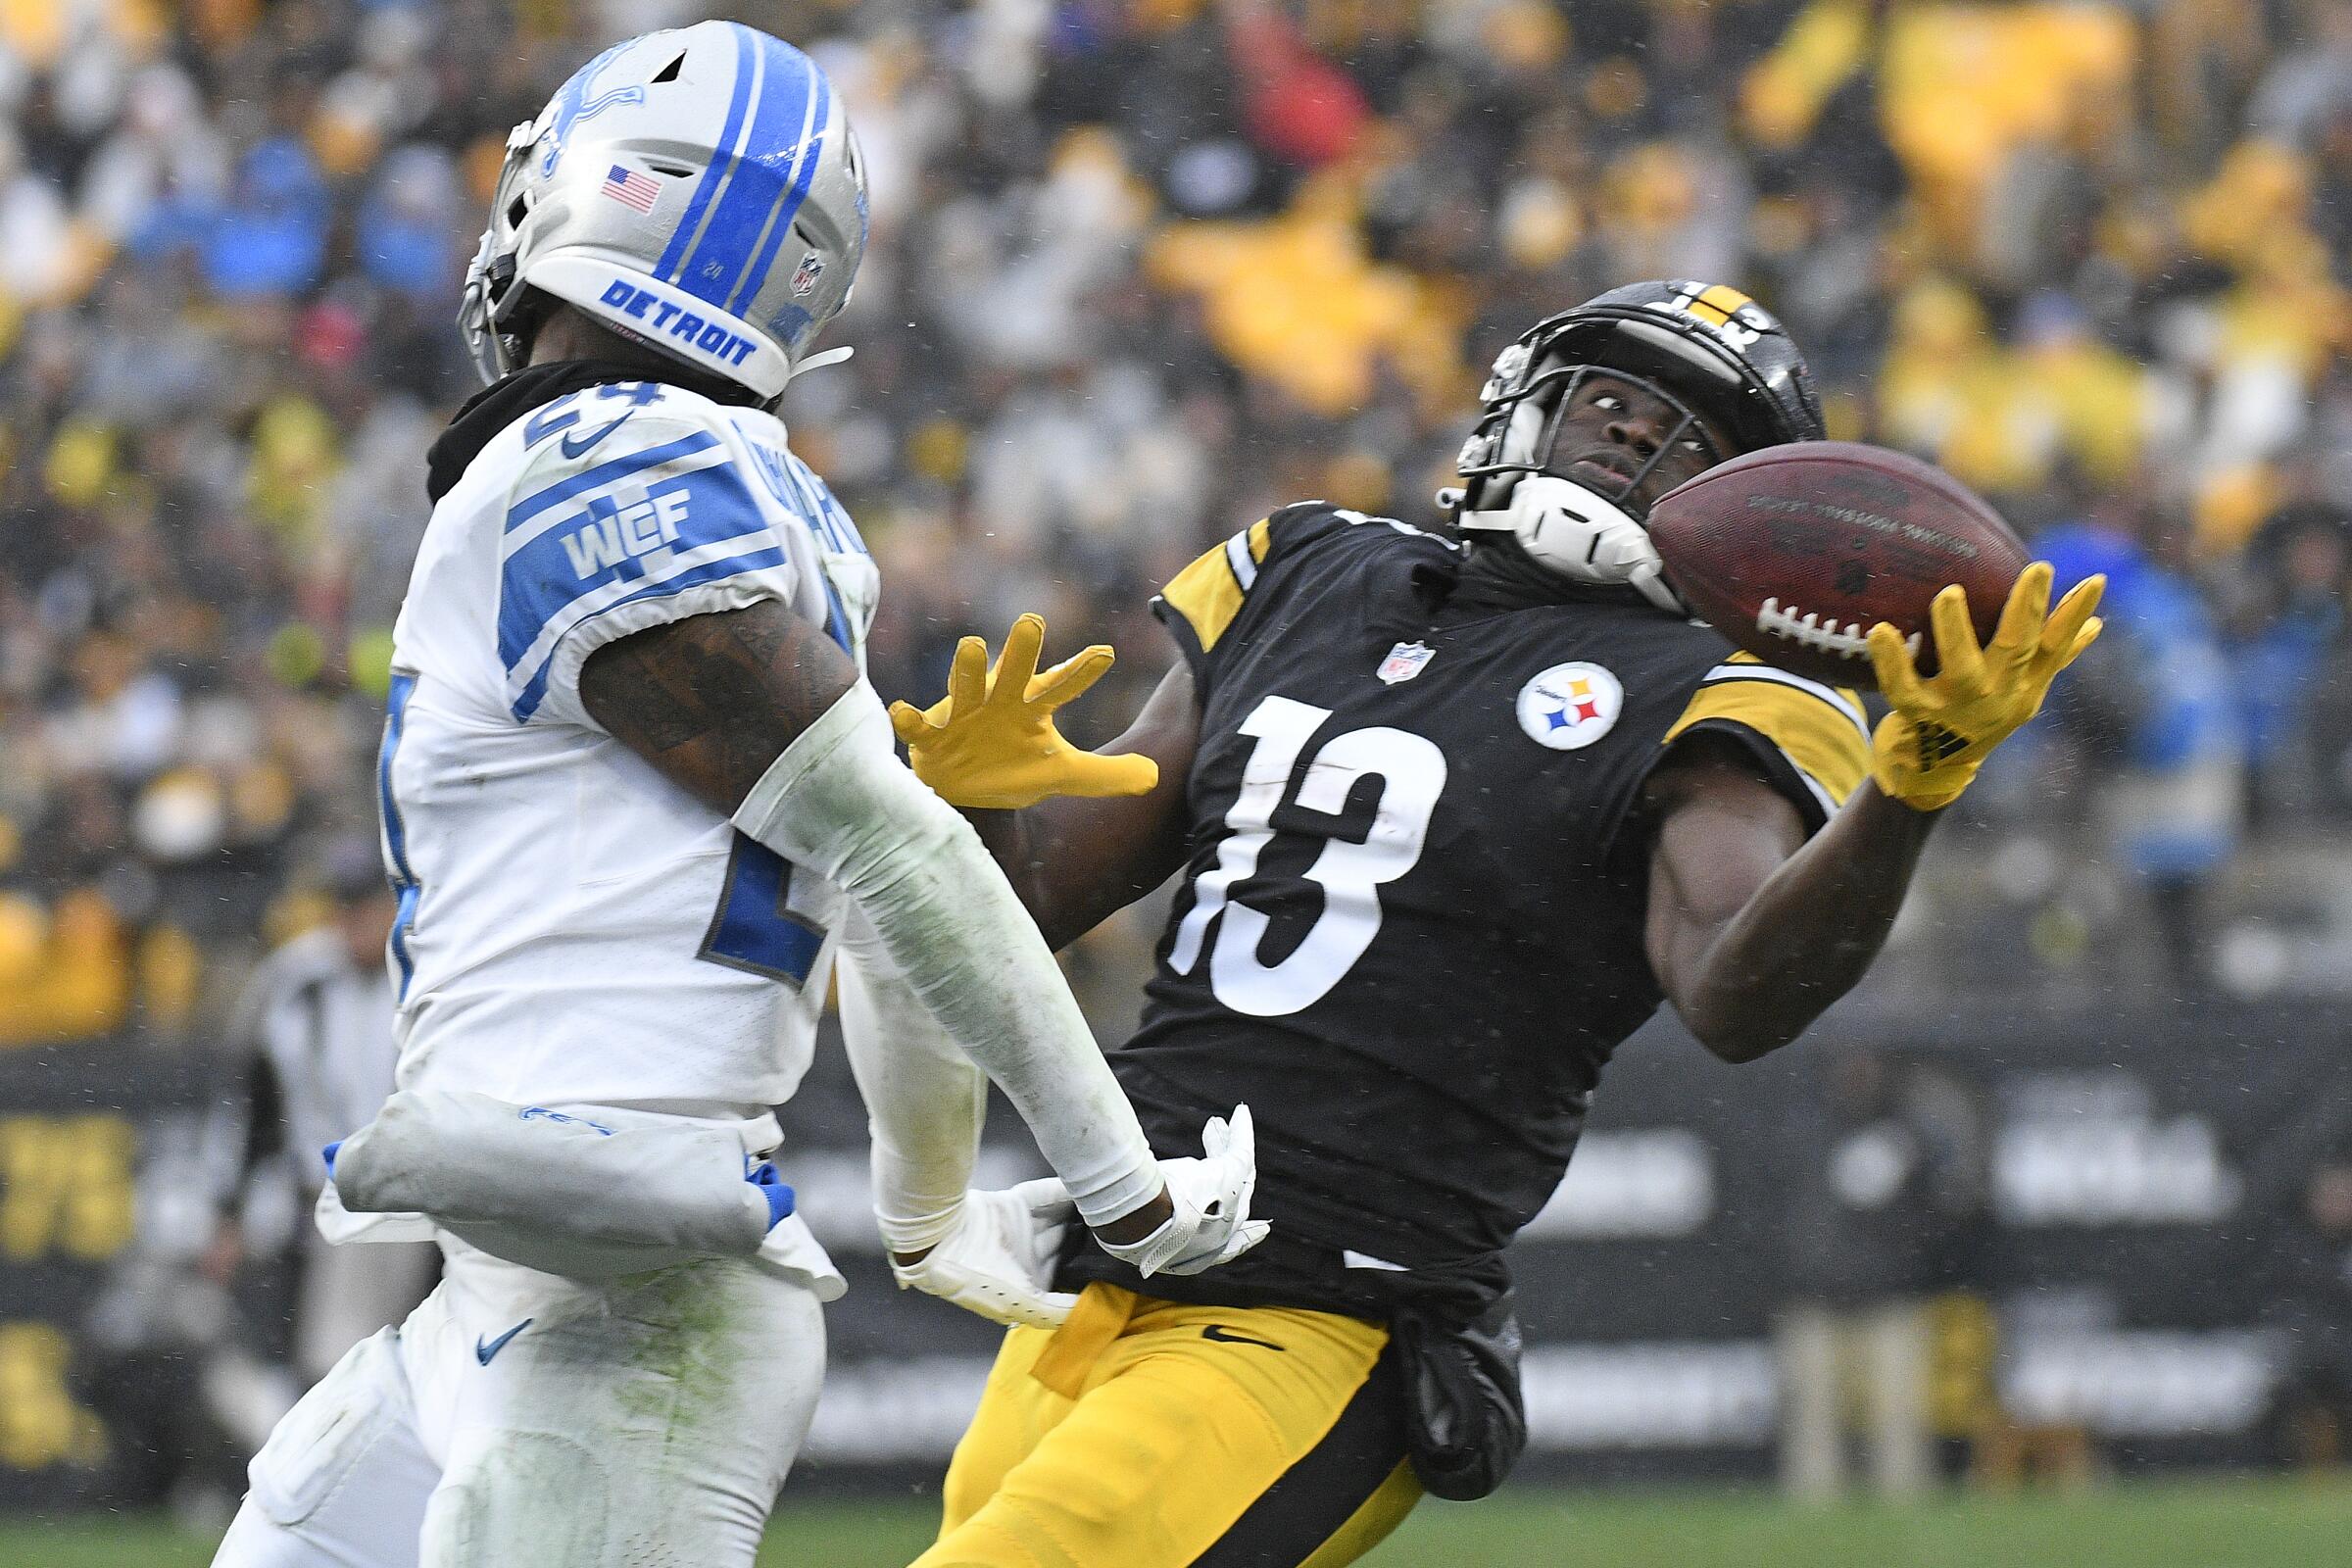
top-left (1870, 562), bottom-right (2107, 811)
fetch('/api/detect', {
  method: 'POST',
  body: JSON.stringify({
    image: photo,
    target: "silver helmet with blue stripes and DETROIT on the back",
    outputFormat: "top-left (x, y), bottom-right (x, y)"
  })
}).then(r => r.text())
top-left (459, 22), bottom-right (865, 400)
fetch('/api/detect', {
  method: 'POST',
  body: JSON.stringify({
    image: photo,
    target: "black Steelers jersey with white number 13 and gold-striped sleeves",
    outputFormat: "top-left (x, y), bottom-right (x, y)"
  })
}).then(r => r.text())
top-left (1070, 503), bottom-right (1868, 1312)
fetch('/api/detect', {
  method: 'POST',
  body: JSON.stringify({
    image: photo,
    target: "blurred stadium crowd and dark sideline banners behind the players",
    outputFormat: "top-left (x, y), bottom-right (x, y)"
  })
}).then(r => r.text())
top-left (0, 0), bottom-right (2352, 1561)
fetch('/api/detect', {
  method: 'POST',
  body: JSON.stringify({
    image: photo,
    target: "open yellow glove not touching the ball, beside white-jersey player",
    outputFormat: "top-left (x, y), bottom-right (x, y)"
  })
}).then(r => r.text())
top-left (889, 615), bottom-right (1159, 811)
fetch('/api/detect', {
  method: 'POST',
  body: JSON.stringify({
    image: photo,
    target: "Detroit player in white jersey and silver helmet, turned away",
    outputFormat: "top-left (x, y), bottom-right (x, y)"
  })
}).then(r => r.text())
top-left (214, 22), bottom-right (1263, 1568)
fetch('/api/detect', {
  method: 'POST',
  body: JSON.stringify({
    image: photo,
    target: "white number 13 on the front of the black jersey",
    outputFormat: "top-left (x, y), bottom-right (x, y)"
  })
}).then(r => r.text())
top-left (1169, 696), bottom-right (1446, 1018)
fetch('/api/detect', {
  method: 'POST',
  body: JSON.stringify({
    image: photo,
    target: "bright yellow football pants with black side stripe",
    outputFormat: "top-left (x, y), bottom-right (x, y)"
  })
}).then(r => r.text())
top-left (915, 1284), bottom-right (1421, 1568)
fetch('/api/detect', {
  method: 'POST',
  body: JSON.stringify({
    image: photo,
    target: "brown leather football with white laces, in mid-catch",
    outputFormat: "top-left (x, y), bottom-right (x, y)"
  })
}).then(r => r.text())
top-left (1648, 442), bottom-right (2025, 689)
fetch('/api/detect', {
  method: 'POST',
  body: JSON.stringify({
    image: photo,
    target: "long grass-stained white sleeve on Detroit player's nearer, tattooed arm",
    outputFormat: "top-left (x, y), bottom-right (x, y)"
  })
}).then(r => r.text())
top-left (734, 682), bottom-right (1164, 1227)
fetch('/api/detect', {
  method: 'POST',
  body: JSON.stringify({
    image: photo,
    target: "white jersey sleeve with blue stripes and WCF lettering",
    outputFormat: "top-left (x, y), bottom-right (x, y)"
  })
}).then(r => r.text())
top-left (496, 404), bottom-right (849, 729)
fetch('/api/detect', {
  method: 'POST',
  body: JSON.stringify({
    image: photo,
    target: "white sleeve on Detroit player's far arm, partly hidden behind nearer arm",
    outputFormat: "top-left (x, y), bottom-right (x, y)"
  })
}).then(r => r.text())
top-left (835, 907), bottom-right (988, 1253)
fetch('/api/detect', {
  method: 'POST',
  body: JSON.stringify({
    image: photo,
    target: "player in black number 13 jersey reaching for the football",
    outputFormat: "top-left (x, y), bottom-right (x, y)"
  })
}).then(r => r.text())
top-left (896, 282), bottom-right (2098, 1568)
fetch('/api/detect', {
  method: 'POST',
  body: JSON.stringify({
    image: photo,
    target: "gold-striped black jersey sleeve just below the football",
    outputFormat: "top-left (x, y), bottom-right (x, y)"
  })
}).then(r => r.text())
top-left (1665, 654), bottom-right (1870, 832)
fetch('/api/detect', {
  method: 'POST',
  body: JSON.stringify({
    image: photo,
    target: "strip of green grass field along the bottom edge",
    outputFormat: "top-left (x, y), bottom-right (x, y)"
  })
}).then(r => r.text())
top-left (0, 1481), bottom-right (2352, 1568)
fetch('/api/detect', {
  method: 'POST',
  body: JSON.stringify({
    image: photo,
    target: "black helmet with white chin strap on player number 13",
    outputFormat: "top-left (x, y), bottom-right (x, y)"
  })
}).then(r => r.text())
top-left (1437, 279), bottom-right (1825, 613)
